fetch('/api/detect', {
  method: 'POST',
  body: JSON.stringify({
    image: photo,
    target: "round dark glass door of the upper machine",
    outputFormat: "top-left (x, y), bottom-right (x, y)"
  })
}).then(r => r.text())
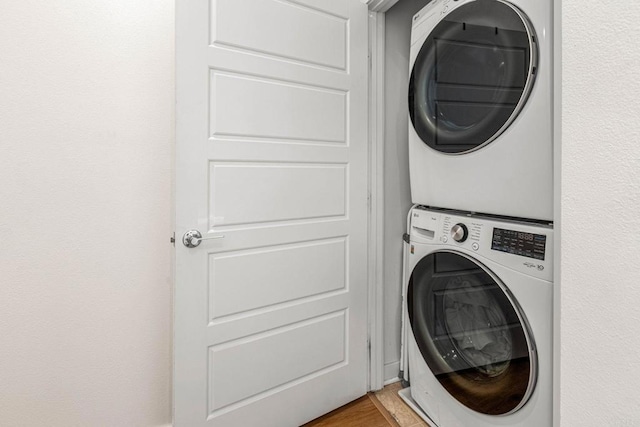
top-left (409, 0), bottom-right (537, 154)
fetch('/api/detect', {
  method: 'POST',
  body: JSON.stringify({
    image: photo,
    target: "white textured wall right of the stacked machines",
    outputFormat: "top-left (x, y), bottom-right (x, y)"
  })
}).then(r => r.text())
top-left (561, 0), bottom-right (640, 427)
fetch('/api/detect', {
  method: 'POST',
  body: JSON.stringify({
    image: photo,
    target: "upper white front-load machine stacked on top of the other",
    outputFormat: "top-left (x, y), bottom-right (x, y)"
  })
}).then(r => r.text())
top-left (408, 0), bottom-right (553, 220)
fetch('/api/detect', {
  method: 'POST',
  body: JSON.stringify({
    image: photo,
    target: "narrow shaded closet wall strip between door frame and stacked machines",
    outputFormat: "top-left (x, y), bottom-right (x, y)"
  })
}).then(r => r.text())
top-left (384, 0), bottom-right (430, 380)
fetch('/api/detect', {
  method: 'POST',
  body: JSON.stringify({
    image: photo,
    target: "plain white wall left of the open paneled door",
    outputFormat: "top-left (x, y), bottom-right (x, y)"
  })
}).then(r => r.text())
top-left (0, 0), bottom-right (174, 427)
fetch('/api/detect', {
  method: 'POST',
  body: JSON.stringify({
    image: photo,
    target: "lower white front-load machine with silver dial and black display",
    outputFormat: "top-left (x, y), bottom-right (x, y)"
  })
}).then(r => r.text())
top-left (404, 207), bottom-right (553, 427)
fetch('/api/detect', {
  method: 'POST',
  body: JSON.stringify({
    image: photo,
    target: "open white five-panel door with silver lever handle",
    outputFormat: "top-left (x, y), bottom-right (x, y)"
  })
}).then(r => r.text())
top-left (174, 0), bottom-right (368, 427)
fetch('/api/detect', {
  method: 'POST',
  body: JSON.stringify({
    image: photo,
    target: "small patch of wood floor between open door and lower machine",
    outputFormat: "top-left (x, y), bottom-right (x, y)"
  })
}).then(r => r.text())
top-left (304, 383), bottom-right (429, 427)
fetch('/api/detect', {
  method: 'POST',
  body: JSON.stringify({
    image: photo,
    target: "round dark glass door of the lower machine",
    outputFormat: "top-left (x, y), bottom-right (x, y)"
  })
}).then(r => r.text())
top-left (407, 251), bottom-right (537, 415)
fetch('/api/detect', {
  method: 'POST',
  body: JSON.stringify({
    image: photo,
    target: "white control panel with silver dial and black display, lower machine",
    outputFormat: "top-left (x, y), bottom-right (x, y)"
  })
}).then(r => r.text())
top-left (409, 207), bottom-right (553, 280)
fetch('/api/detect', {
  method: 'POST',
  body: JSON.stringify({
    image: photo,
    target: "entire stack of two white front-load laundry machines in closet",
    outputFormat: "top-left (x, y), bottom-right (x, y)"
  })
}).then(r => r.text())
top-left (403, 0), bottom-right (553, 427)
